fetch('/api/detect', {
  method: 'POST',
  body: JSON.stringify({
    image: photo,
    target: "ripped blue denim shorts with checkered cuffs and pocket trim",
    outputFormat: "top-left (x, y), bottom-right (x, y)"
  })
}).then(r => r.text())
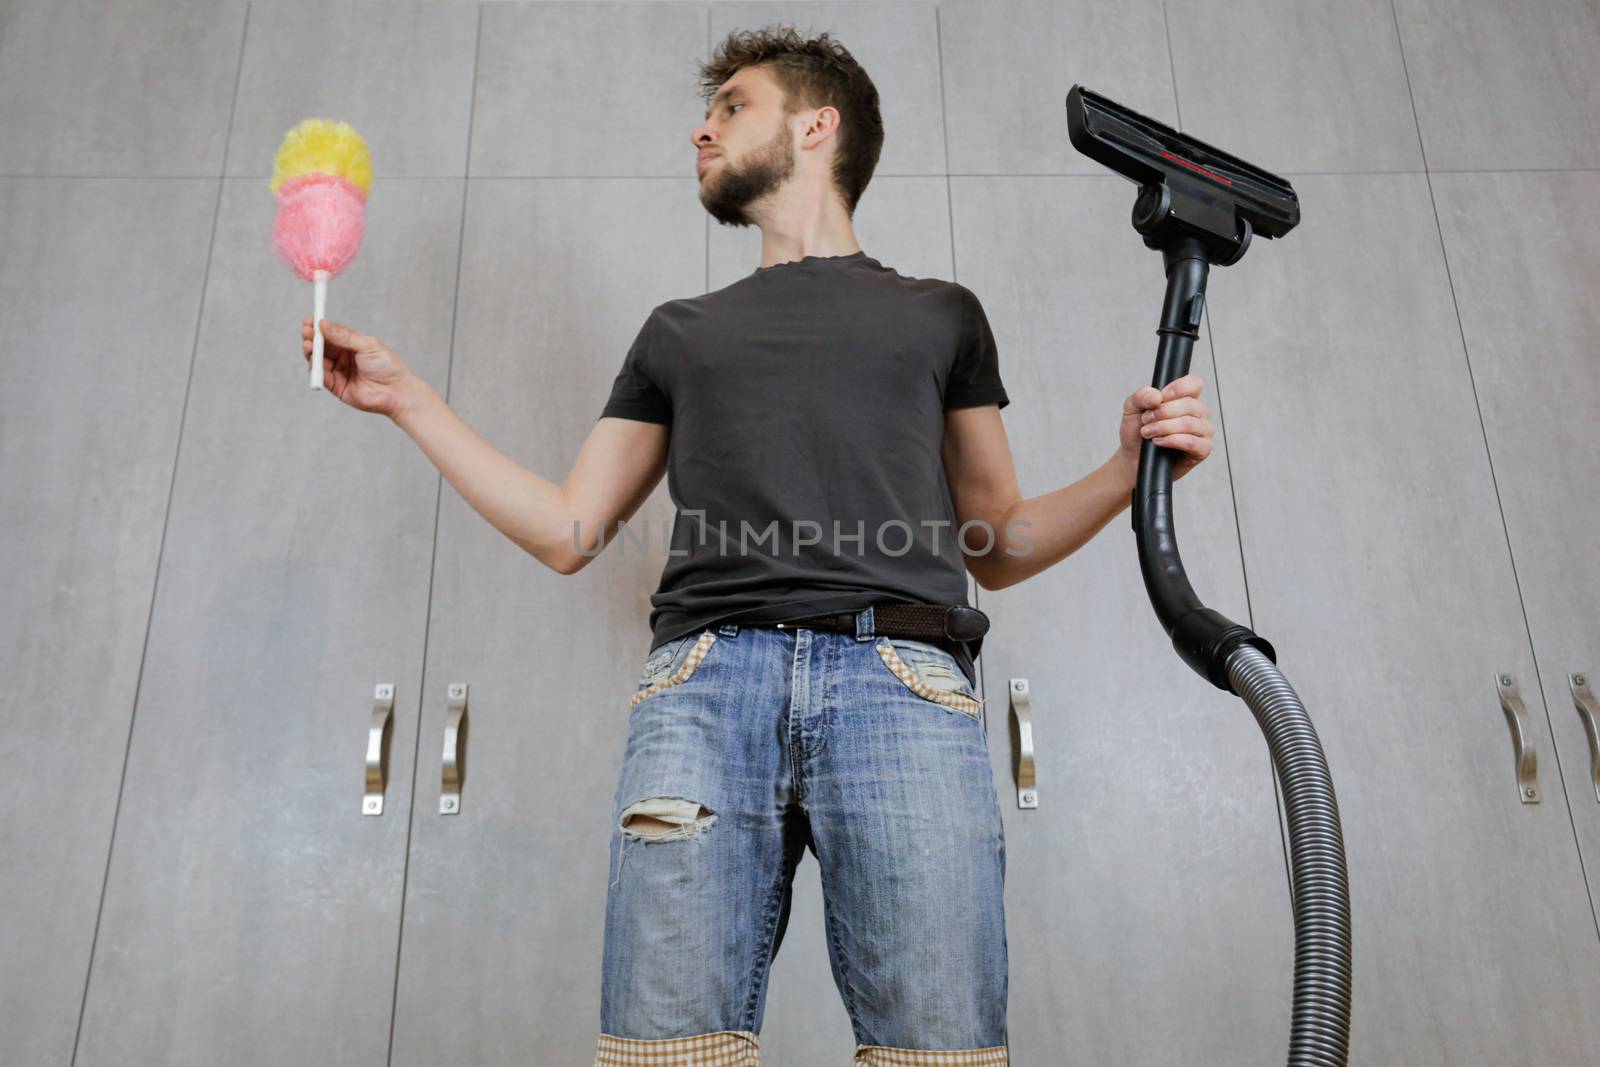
top-left (595, 613), bottom-right (1008, 1067)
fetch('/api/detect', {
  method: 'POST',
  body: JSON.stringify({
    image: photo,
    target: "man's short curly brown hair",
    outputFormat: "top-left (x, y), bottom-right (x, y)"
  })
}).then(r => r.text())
top-left (699, 24), bottom-right (883, 218)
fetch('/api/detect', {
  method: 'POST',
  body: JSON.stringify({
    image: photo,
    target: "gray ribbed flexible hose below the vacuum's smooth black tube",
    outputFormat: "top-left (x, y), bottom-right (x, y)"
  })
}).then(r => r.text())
top-left (1227, 645), bottom-right (1350, 1067)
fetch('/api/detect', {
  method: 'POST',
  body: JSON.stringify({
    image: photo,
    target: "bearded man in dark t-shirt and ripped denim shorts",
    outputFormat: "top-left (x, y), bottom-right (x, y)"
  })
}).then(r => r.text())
top-left (302, 27), bottom-right (1213, 1067)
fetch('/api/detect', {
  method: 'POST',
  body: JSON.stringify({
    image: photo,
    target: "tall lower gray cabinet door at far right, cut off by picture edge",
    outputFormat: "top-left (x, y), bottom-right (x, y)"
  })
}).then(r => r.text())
top-left (1434, 171), bottom-right (1600, 915)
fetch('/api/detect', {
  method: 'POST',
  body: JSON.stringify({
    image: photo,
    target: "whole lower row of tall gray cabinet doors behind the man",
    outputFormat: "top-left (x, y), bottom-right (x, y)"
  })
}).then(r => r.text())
top-left (12, 106), bottom-right (1600, 1067)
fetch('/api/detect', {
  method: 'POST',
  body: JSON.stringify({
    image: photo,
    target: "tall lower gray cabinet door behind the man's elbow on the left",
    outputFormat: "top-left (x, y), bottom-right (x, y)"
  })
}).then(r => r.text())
top-left (392, 178), bottom-right (706, 1067)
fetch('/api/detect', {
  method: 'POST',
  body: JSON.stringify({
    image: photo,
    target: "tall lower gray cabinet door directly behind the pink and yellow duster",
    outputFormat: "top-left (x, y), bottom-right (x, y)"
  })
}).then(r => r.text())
top-left (77, 178), bottom-right (462, 1067)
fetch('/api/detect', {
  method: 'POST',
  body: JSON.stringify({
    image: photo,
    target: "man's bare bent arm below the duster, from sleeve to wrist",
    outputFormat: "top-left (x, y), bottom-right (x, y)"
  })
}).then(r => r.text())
top-left (392, 376), bottom-right (670, 574)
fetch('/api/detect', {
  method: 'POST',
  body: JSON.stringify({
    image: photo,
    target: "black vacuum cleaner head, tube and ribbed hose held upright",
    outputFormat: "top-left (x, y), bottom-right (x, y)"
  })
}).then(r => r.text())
top-left (1067, 85), bottom-right (1350, 1067)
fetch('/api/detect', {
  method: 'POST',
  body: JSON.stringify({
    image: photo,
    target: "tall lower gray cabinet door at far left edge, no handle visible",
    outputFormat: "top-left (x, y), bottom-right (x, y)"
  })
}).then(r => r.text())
top-left (0, 178), bottom-right (216, 1064)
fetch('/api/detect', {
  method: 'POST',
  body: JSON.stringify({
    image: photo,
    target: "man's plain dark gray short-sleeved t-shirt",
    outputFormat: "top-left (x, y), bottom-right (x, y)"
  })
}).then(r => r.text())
top-left (600, 251), bottom-right (1010, 677)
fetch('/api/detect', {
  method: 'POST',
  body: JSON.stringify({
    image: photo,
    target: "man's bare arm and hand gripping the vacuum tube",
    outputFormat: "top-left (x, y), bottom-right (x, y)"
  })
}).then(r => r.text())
top-left (942, 374), bottom-right (1214, 589)
